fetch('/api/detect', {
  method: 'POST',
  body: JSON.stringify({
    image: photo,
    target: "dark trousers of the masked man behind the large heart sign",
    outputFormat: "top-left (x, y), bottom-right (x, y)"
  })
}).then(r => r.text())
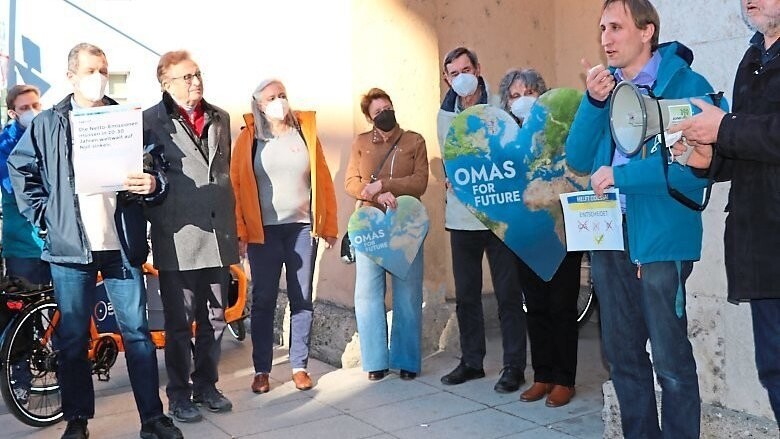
top-left (450, 230), bottom-right (527, 370)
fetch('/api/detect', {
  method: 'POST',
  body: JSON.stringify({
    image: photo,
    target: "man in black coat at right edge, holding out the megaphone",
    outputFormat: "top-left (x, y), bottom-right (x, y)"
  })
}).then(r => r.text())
top-left (674, 0), bottom-right (780, 423)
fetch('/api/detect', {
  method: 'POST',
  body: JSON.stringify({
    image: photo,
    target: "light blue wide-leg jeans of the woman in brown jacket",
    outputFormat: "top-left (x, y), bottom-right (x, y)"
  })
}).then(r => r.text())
top-left (355, 247), bottom-right (423, 373)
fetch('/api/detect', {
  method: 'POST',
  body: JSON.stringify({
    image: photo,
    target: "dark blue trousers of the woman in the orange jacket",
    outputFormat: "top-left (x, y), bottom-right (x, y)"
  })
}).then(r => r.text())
top-left (247, 223), bottom-right (317, 373)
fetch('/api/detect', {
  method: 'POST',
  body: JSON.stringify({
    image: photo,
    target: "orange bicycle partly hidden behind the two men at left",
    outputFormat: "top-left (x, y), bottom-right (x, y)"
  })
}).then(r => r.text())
top-left (0, 264), bottom-right (249, 427)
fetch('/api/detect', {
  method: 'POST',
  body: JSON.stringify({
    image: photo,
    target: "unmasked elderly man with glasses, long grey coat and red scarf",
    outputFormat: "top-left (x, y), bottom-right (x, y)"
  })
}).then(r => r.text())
top-left (144, 51), bottom-right (238, 422)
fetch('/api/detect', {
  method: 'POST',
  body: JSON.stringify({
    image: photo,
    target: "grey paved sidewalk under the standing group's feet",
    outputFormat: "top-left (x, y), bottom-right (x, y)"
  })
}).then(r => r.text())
top-left (0, 323), bottom-right (607, 439)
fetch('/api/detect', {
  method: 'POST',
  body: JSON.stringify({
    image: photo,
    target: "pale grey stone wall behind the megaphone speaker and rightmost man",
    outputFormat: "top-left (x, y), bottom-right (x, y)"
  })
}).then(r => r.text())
top-left (655, 0), bottom-right (773, 419)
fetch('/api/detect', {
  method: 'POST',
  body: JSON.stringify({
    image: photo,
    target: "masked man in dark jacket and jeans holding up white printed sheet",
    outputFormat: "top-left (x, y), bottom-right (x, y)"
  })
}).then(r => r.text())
top-left (8, 43), bottom-right (182, 439)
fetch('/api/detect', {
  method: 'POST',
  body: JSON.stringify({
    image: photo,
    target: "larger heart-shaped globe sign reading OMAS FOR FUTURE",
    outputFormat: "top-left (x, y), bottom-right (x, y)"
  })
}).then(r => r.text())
top-left (444, 88), bottom-right (590, 280)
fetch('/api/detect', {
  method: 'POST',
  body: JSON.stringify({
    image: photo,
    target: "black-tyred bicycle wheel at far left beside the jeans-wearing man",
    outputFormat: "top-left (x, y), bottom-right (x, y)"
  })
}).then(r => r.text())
top-left (0, 298), bottom-right (62, 427)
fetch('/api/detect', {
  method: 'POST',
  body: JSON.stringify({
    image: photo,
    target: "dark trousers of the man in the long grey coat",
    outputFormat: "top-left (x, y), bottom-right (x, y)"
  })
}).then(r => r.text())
top-left (160, 267), bottom-right (230, 402)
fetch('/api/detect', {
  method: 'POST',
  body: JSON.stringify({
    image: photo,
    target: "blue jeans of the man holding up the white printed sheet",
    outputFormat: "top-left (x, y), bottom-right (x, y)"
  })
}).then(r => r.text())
top-left (51, 250), bottom-right (163, 422)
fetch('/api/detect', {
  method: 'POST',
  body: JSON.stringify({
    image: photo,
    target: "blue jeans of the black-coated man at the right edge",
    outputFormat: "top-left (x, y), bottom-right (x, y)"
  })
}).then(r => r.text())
top-left (750, 299), bottom-right (780, 426)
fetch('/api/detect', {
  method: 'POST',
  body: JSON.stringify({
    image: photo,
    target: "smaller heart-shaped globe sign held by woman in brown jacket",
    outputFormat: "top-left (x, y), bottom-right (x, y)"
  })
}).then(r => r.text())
top-left (347, 195), bottom-right (428, 279)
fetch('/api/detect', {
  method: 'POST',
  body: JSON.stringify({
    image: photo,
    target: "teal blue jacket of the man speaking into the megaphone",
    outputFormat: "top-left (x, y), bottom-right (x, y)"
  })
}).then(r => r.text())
top-left (566, 42), bottom-right (724, 266)
